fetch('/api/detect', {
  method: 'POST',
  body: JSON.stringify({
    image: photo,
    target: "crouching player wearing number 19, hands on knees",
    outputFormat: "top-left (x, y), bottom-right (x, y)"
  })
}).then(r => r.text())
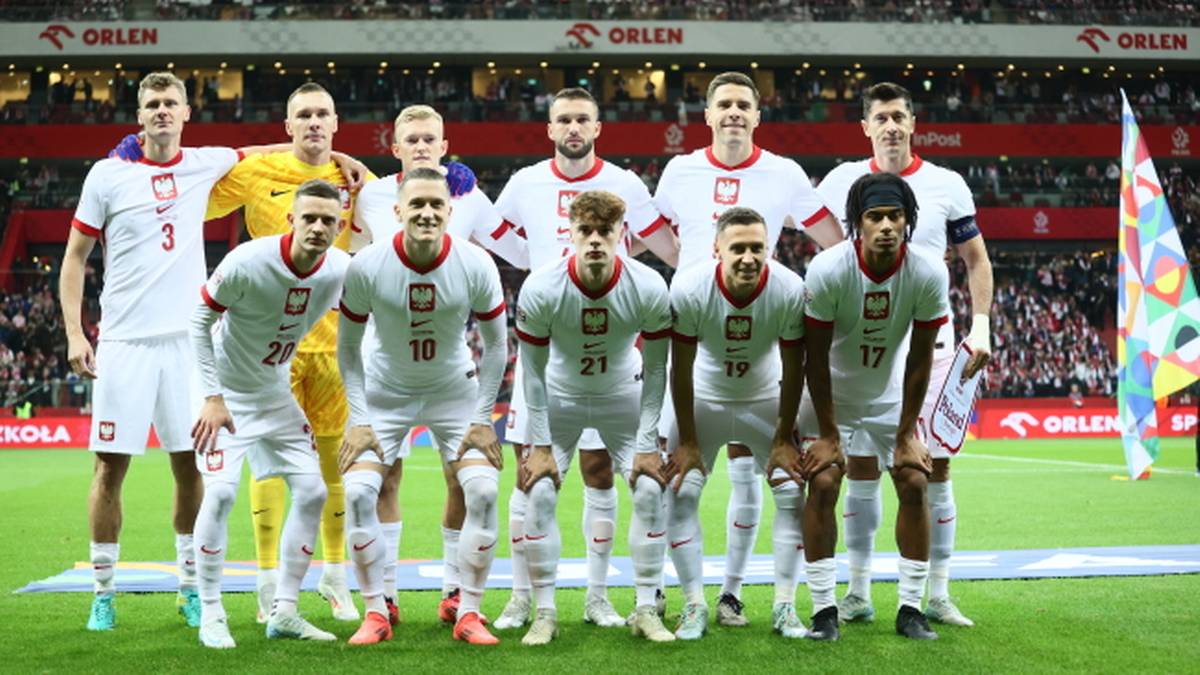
top-left (667, 207), bottom-right (805, 640)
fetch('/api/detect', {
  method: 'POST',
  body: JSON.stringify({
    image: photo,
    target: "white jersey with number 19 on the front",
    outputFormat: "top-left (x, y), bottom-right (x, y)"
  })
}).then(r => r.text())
top-left (671, 259), bottom-right (804, 402)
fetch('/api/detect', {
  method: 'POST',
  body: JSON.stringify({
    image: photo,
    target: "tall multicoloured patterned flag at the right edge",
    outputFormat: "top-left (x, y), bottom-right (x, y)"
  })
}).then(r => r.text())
top-left (1117, 91), bottom-right (1200, 478)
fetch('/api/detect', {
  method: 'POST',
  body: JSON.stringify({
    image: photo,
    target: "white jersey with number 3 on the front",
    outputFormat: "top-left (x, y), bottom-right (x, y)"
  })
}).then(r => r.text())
top-left (71, 148), bottom-right (240, 340)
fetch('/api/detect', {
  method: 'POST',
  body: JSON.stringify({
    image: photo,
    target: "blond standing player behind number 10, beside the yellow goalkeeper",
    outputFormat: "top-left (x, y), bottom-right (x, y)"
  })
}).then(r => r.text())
top-left (350, 106), bottom-right (529, 623)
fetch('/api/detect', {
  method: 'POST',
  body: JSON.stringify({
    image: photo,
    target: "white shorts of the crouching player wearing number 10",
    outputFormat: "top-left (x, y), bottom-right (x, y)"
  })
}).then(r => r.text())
top-left (356, 377), bottom-right (487, 466)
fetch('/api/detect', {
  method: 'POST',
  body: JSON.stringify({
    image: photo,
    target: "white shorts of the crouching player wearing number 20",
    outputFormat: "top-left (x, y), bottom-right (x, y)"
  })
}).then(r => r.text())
top-left (196, 395), bottom-right (320, 484)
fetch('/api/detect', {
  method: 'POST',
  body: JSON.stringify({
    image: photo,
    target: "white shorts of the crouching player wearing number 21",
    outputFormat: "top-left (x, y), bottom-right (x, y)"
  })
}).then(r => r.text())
top-left (546, 387), bottom-right (642, 477)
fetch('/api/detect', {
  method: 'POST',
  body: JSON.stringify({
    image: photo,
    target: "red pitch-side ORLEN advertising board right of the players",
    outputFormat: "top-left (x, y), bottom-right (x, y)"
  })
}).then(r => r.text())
top-left (976, 400), bottom-right (1196, 438)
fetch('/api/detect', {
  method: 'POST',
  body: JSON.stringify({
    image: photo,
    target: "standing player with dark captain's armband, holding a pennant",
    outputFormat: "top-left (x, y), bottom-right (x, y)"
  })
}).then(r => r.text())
top-left (817, 82), bottom-right (992, 626)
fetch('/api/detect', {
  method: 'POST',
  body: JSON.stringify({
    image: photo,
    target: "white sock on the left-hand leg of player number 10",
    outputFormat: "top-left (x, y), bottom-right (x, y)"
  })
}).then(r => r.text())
top-left (342, 471), bottom-right (388, 598)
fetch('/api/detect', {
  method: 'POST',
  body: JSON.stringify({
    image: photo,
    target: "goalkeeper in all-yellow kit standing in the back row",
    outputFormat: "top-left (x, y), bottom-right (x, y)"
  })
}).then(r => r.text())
top-left (208, 82), bottom-right (373, 623)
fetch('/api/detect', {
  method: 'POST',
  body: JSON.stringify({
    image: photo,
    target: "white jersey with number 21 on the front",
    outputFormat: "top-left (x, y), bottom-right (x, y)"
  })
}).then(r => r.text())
top-left (517, 255), bottom-right (671, 396)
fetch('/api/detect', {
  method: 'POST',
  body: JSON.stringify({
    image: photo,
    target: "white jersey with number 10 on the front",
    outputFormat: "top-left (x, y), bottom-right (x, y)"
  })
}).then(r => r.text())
top-left (341, 232), bottom-right (504, 396)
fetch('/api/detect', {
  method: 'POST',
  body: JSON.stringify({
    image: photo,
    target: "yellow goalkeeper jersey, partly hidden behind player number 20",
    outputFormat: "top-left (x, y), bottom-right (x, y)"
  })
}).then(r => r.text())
top-left (205, 151), bottom-right (376, 352)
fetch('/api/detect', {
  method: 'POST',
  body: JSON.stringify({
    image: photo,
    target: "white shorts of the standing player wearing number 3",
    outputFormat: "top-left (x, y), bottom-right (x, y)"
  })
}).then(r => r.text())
top-left (88, 334), bottom-right (202, 455)
